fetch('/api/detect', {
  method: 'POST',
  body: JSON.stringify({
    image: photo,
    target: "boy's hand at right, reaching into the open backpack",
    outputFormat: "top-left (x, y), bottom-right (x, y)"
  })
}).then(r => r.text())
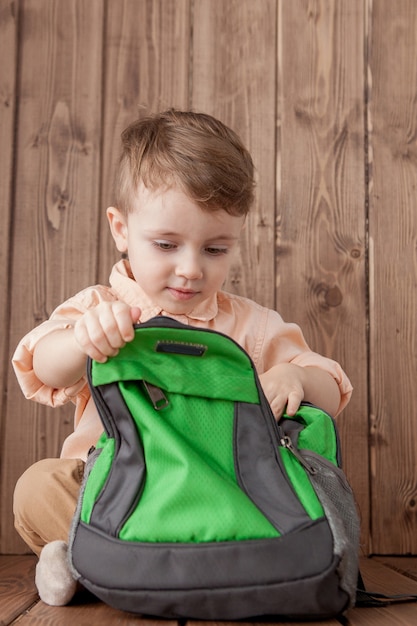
top-left (259, 363), bottom-right (304, 419)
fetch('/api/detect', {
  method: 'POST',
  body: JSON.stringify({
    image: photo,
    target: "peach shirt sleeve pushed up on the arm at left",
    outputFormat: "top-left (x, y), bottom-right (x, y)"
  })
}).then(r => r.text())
top-left (12, 285), bottom-right (116, 407)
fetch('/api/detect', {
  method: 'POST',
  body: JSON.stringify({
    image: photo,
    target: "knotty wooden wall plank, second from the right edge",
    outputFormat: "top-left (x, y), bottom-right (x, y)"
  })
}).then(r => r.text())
top-left (276, 0), bottom-right (369, 551)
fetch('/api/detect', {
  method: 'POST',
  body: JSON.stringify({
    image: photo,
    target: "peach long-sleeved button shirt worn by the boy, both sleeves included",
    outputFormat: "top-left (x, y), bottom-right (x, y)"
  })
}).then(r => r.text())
top-left (12, 261), bottom-right (352, 460)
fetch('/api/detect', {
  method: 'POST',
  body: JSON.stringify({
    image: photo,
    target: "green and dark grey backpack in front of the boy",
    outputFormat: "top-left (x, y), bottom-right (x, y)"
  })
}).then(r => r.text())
top-left (69, 316), bottom-right (359, 620)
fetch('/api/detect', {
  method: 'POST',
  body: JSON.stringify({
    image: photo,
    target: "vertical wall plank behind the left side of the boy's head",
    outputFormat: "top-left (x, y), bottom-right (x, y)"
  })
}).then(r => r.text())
top-left (97, 0), bottom-right (190, 284)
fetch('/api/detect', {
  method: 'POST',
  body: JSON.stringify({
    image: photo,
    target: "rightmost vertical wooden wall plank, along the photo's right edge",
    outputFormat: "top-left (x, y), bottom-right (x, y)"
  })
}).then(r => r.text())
top-left (369, 0), bottom-right (417, 554)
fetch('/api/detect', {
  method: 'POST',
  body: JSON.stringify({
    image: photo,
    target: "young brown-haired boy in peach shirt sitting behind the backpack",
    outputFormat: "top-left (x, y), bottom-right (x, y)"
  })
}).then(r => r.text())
top-left (13, 110), bottom-right (352, 605)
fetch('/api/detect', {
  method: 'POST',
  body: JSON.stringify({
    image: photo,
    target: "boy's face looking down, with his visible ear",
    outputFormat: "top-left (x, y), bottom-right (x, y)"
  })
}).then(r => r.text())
top-left (107, 185), bottom-right (244, 315)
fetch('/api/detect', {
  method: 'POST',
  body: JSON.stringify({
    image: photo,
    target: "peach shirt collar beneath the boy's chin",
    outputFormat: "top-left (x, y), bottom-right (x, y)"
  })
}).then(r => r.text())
top-left (110, 259), bottom-right (218, 322)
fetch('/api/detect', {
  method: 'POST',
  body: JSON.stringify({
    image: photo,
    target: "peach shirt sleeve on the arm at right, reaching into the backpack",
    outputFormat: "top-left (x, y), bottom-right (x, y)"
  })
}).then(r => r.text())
top-left (258, 310), bottom-right (353, 415)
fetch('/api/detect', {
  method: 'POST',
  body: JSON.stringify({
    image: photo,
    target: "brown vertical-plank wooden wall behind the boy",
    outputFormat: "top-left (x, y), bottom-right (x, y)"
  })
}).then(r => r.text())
top-left (0, 0), bottom-right (417, 554)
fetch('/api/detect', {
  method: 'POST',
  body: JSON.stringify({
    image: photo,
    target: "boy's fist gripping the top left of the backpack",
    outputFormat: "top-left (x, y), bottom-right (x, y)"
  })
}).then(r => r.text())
top-left (74, 301), bottom-right (141, 363)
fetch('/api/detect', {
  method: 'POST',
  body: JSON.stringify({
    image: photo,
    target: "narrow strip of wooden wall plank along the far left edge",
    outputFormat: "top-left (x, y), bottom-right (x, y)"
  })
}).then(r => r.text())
top-left (0, 0), bottom-right (17, 556)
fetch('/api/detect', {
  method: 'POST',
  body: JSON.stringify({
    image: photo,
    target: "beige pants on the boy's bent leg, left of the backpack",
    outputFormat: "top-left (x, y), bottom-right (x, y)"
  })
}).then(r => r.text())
top-left (13, 459), bottom-right (84, 555)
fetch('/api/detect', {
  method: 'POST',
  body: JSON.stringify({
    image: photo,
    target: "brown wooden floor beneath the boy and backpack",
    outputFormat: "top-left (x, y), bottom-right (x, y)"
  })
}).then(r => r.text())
top-left (0, 556), bottom-right (417, 626)
